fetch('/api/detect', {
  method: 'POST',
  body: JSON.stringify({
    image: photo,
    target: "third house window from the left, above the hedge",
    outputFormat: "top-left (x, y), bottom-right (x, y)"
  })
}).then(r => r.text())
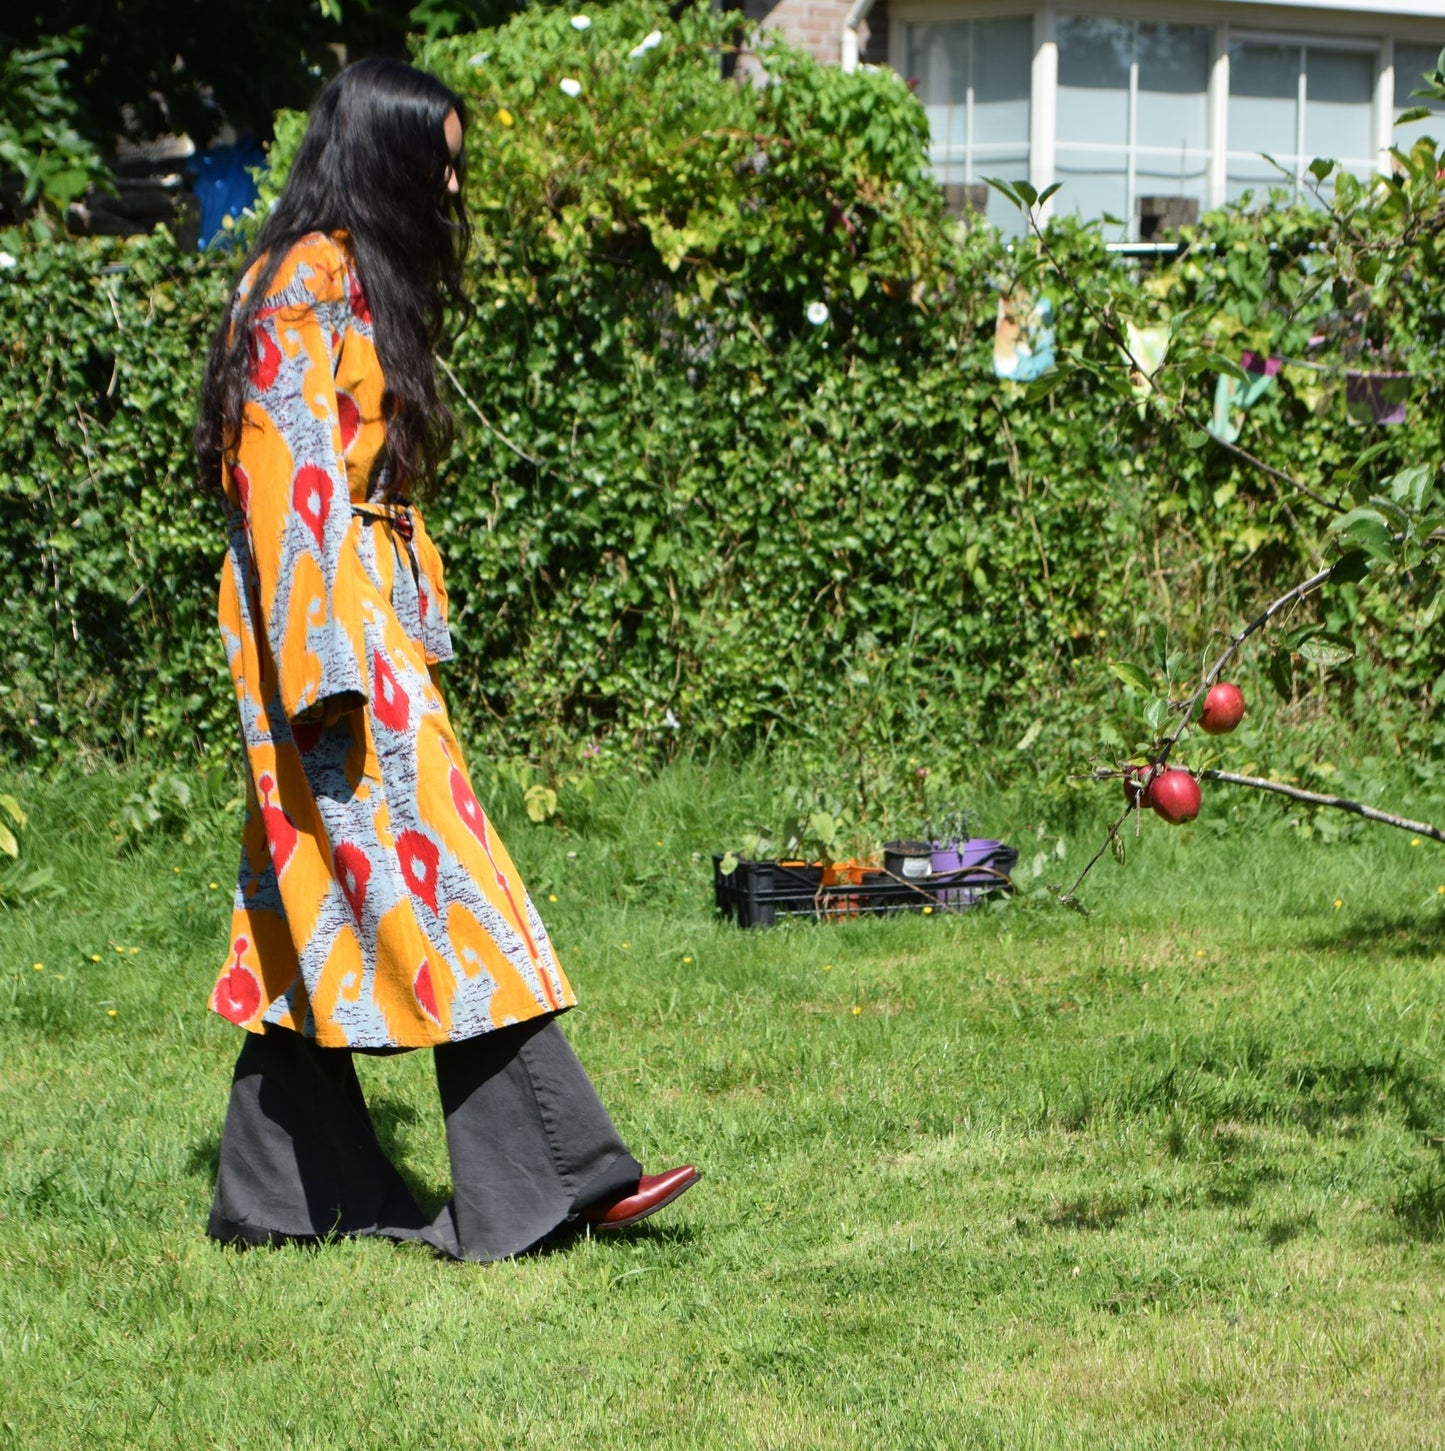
top-left (1226, 39), bottom-right (1375, 200)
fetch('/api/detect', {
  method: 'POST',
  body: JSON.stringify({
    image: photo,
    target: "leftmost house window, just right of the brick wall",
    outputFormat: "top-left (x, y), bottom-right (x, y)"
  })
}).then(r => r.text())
top-left (907, 16), bottom-right (1033, 231)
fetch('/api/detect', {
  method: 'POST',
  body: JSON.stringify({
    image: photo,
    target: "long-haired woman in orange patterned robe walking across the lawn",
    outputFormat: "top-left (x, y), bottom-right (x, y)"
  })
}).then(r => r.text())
top-left (196, 61), bottom-right (698, 1259)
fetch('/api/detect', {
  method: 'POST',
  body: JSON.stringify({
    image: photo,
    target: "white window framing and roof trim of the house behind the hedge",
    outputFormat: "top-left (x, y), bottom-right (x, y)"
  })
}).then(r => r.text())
top-left (888, 0), bottom-right (1445, 234)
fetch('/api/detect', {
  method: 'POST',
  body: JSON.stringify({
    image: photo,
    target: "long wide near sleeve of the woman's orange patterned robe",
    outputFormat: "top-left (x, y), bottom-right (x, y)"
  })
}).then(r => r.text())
top-left (231, 271), bottom-right (367, 720)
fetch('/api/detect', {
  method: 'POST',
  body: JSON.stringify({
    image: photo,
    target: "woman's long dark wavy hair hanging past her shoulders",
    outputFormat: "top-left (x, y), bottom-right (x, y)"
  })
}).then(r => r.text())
top-left (193, 59), bottom-right (472, 496)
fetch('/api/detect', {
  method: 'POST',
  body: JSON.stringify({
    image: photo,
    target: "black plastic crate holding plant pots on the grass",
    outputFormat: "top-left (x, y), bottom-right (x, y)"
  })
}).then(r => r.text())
top-left (712, 846), bottom-right (1018, 927)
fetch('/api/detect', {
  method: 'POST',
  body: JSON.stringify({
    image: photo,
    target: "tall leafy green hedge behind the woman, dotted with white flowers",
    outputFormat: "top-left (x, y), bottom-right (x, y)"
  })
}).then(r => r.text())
top-left (0, 0), bottom-right (1445, 783)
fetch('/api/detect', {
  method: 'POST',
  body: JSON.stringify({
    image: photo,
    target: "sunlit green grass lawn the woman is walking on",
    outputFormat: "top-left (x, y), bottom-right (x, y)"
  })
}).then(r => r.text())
top-left (0, 768), bottom-right (1445, 1451)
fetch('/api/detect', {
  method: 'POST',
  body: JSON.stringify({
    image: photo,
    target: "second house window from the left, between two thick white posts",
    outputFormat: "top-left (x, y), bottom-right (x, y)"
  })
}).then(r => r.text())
top-left (1056, 16), bottom-right (1213, 237)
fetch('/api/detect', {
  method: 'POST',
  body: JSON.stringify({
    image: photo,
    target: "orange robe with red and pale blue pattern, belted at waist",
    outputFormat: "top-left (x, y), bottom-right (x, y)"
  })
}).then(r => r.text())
top-left (212, 234), bottom-right (576, 1048)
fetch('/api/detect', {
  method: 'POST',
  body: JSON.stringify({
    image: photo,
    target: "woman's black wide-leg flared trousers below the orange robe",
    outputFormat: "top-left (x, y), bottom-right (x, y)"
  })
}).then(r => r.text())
top-left (207, 1017), bottom-right (641, 1261)
